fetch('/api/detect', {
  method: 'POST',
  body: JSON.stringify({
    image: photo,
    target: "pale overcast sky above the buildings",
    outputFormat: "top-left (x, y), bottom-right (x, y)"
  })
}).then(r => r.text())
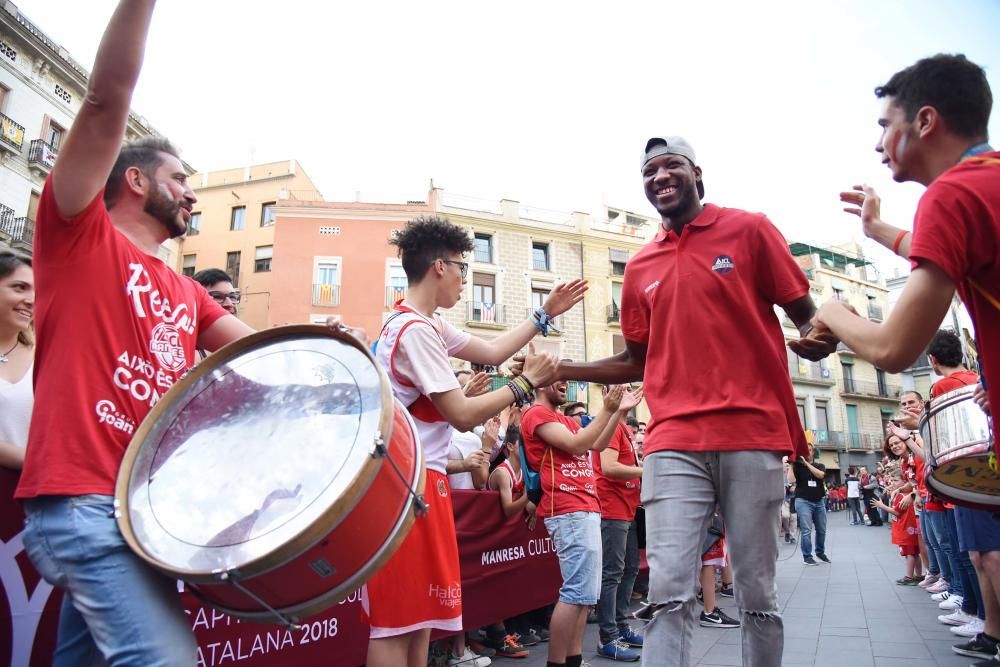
top-left (16, 0), bottom-right (1000, 271)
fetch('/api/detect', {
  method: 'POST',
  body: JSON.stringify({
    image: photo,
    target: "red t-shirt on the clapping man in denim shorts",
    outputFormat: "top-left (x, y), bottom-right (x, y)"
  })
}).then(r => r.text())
top-left (521, 405), bottom-right (601, 517)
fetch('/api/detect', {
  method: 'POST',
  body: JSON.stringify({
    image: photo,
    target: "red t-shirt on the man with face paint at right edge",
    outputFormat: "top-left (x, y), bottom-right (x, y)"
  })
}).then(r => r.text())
top-left (910, 151), bottom-right (1000, 420)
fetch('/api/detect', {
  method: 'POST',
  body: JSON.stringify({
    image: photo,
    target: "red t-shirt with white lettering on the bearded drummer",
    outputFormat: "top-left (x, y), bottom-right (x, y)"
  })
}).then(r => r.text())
top-left (15, 178), bottom-right (226, 498)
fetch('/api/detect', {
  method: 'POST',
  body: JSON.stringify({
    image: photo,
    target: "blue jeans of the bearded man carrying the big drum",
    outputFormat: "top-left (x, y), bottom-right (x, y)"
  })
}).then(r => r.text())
top-left (24, 495), bottom-right (197, 667)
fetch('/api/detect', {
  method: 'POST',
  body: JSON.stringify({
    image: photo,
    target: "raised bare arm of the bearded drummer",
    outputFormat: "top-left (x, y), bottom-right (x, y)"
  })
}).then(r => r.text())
top-left (51, 0), bottom-right (156, 217)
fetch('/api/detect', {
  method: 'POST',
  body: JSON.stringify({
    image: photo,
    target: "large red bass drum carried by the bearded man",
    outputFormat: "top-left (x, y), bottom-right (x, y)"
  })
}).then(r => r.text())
top-left (115, 325), bottom-right (424, 624)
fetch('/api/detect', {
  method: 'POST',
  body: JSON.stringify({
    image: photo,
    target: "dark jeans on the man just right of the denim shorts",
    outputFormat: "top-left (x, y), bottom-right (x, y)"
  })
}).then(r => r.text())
top-left (597, 519), bottom-right (639, 644)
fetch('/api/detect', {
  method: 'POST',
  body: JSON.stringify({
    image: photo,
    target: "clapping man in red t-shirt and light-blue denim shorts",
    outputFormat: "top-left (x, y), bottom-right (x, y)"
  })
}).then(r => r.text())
top-left (521, 381), bottom-right (642, 667)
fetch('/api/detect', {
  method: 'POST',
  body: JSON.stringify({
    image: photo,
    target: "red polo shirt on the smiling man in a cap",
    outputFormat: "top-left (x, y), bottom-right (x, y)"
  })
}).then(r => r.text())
top-left (621, 204), bottom-right (809, 456)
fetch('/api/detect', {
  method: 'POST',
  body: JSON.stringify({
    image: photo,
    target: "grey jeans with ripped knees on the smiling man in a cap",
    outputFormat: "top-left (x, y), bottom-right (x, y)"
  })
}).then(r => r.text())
top-left (642, 451), bottom-right (784, 667)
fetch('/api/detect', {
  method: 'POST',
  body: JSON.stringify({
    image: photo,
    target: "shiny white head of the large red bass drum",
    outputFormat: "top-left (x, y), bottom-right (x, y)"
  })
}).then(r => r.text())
top-left (116, 326), bottom-right (392, 581)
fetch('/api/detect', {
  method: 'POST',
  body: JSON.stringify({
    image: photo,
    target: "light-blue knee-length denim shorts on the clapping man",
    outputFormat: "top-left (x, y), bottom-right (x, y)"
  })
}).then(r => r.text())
top-left (545, 512), bottom-right (602, 606)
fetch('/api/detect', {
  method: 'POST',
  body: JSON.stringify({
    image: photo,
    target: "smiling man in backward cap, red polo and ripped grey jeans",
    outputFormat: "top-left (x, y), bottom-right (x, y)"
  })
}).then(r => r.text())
top-left (559, 137), bottom-right (836, 667)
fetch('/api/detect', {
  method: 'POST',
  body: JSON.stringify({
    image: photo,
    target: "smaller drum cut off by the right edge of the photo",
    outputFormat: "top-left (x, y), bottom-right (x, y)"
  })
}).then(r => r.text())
top-left (920, 385), bottom-right (1000, 510)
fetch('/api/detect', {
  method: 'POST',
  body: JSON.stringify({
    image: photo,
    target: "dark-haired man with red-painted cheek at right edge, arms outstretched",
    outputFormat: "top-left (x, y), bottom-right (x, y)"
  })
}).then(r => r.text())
top-left (808, 54), bottom-right (1000, 664)
